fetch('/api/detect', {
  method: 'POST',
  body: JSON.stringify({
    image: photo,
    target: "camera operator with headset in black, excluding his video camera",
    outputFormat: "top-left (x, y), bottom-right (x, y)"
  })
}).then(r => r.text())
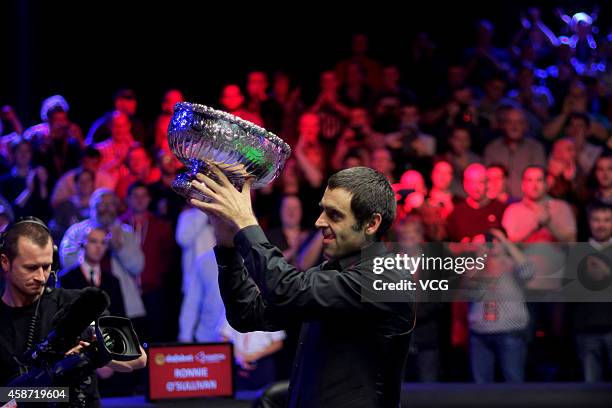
top-left (0, 218), bottom-right (146, 407)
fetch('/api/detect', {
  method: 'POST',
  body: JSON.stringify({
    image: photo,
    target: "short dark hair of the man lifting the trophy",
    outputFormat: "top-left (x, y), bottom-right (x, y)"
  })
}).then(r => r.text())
top-left (327, 167), bottom-right (397, 239)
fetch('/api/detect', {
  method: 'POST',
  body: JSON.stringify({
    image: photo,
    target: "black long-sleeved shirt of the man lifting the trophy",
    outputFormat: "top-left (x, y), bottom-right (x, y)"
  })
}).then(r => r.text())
top-left (215, 226), bottom-right (415, 407)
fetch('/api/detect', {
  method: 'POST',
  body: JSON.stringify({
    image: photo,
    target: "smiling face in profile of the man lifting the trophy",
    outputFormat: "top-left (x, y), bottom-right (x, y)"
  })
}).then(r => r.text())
top-left (315, 188), bottom-right (368, 259)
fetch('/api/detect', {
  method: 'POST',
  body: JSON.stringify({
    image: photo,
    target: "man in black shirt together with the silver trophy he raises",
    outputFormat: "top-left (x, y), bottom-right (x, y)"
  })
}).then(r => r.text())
top-left (168, 103), bottom-right (414, 407)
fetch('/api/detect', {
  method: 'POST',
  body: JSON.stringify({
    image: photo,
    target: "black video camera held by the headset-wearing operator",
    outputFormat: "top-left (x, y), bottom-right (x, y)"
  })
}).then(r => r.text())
top-left (8, 288), bottom-right (141, 387)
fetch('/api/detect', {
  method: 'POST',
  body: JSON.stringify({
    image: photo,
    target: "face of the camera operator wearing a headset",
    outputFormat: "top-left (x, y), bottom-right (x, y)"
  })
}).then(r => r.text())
top-left (0, 236), bottom-right (53, 301)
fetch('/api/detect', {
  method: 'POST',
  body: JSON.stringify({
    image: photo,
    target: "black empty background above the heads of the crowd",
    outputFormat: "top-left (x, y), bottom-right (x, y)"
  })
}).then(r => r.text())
top-left (0, 0), bottom-right (611, 130)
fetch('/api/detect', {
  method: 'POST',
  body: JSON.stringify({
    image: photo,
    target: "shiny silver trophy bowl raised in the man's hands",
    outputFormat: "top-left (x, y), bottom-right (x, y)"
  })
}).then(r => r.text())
top-left (168, 102), bottom-right (291, 202)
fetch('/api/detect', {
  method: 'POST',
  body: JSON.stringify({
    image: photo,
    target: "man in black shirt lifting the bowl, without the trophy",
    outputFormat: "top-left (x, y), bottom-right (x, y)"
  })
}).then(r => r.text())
top-left (191, 167), bottom-right (414, 407)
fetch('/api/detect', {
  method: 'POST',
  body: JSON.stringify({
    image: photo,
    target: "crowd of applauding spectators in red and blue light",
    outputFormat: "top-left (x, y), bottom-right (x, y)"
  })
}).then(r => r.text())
top-left (0, 9), bottom-right (612, 387)
